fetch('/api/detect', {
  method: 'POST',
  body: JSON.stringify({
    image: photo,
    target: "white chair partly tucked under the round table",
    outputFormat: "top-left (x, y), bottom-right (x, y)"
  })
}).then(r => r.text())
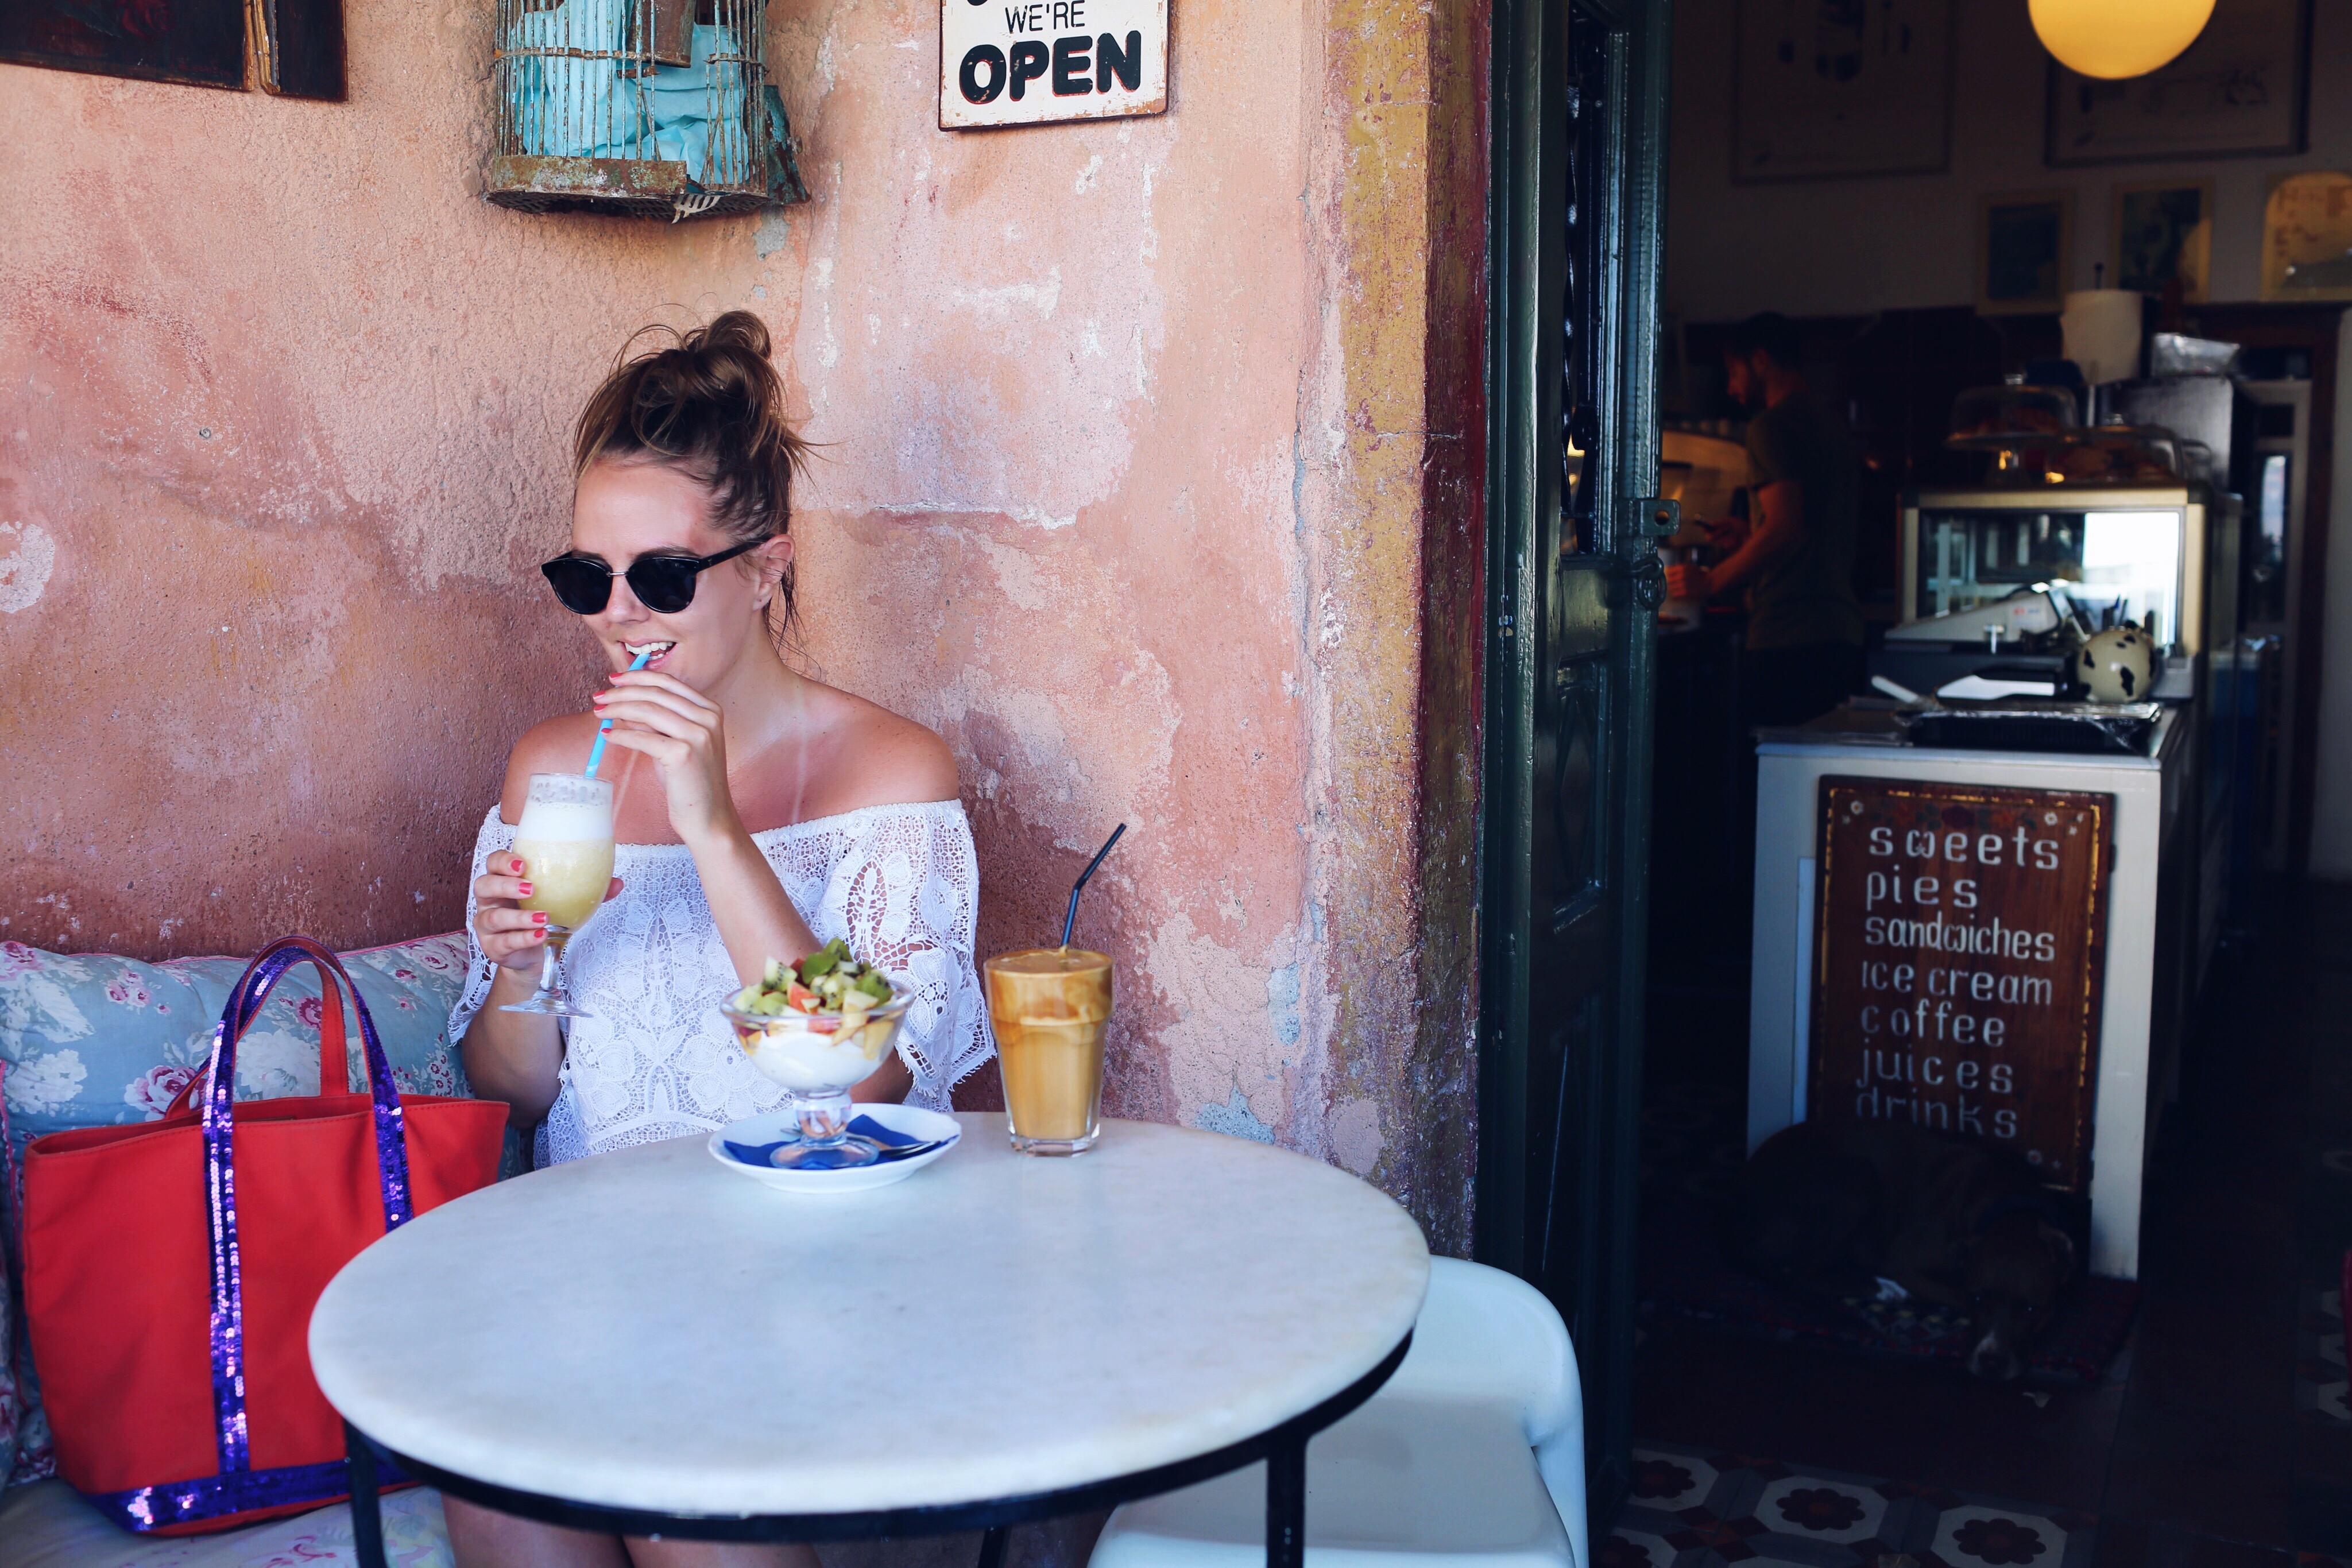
top-left (1089, 1258), bottom-right (1590, 1568)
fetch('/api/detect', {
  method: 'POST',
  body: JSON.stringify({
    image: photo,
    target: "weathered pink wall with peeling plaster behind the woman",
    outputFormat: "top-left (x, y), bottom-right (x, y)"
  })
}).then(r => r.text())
top-left (0, 0), bottom-right (1487, 1250)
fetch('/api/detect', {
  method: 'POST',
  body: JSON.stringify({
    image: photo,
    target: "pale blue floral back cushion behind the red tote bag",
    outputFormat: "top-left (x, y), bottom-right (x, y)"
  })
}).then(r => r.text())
top-left (0, 933), bottom-right (477, 1484)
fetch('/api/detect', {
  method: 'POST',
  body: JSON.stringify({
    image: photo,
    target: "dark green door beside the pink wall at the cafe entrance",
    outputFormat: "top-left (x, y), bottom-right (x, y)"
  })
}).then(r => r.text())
top-left (1477, 0), bottom-right (1670, 1542)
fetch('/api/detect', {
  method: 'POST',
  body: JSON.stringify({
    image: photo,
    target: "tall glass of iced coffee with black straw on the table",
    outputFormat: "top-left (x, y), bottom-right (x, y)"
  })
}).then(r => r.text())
top-left (985, 947), bottom-right (1110, 1154)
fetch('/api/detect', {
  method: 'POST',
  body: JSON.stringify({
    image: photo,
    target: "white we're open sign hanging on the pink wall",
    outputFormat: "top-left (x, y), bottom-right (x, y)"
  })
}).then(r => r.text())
top-left (938, 0), bottom-right (1169, 131)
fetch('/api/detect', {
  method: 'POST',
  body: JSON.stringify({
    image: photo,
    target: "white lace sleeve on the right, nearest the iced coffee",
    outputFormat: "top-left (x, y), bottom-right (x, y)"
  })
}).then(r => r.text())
top-left (809, 802), bottom-right (990, 1110)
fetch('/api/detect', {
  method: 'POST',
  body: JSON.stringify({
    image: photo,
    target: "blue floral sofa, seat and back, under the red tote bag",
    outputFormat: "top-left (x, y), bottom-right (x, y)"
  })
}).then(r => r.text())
top-left (0, 933), bottom-right (479, 1568)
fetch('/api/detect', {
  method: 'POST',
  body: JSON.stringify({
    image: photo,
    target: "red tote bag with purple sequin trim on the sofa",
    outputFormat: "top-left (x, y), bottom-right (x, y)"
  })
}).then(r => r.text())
top-left (21, 936), bottom-right (506, 1535)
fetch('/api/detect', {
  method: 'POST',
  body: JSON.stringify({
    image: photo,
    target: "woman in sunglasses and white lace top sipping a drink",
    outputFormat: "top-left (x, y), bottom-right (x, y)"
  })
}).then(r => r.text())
top-left (444, 310), bottom-right (988, 1568)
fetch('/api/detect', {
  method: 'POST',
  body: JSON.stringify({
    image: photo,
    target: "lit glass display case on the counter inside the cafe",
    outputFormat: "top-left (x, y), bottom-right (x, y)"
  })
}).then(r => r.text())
top-left (1903, 484), bottom-right (2234, 653)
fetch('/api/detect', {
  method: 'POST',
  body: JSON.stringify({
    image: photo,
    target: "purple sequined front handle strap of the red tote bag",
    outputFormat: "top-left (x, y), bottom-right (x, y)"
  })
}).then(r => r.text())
top-left (202, 936), bottom-right (414, 1476)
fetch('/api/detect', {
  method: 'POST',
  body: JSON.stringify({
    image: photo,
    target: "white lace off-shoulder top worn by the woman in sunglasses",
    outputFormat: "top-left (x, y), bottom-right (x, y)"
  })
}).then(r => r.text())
top-left (449, 799), bottom-right (990, 1166)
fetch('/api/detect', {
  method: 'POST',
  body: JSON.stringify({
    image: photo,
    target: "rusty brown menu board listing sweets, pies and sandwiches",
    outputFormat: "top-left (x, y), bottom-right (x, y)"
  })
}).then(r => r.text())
top-left (1809, 778), bottom-right (2114, 1190)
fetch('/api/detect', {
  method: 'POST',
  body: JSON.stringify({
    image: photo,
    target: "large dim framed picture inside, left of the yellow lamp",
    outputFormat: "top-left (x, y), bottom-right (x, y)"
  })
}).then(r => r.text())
top-left (1731, 0), bottom-right (1957, 185)
